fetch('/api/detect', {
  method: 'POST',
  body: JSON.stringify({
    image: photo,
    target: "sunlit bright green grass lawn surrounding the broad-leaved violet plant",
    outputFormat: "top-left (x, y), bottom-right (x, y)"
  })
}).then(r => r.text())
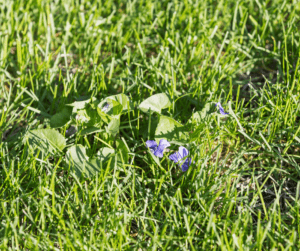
top-left (0, 0), bottom-right (300, 251)
